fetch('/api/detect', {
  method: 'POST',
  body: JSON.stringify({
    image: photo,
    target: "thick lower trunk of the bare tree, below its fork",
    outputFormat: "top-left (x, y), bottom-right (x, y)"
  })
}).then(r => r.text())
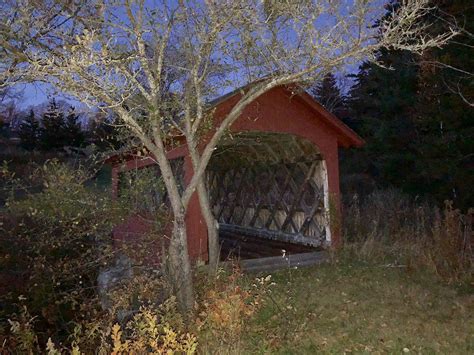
top-left (169, 215), bottom-right (194, 318)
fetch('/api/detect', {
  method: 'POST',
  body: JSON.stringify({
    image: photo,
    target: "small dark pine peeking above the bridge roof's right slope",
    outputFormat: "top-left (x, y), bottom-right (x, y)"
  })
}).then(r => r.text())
top-left (310, 73), bottom-right (345, 117)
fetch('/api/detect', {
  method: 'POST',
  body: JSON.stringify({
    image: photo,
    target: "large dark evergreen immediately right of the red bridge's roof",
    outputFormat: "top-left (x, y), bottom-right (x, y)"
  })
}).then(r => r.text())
top-left (343, 50), bottom-right (419, 193)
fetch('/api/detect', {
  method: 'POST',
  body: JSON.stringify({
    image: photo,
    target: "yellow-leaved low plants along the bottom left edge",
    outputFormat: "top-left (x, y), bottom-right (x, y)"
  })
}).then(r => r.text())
top-left (4, 300), bottom-right (198, 355)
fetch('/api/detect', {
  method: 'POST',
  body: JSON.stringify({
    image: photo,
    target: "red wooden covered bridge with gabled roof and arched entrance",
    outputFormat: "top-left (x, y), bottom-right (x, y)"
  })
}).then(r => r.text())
top-left (110, 87), bottom-right (363, 268)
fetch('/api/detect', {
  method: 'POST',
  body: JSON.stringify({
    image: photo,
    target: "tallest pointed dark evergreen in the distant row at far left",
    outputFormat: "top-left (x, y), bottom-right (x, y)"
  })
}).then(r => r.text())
top-left (40, 99), bottom-right (66, 150)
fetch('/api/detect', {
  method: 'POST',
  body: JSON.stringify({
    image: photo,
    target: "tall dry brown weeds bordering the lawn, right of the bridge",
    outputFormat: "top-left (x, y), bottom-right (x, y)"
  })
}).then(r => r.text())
top-left (343, 190), bottom-right (474, 281)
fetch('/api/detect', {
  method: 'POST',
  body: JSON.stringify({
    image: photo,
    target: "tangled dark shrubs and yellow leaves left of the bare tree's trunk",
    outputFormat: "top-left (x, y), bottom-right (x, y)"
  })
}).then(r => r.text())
top-left (0, 160), bottom-right (197, 354)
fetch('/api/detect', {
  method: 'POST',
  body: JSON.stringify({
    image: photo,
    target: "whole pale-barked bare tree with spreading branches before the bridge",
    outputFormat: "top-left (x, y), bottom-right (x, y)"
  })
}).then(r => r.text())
top-left (0, 0), bottom-right (456, 310)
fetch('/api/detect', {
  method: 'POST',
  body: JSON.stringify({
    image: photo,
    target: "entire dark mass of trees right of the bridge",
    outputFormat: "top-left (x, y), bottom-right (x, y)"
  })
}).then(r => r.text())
top-left (313, 0), bottom-right (474, 210)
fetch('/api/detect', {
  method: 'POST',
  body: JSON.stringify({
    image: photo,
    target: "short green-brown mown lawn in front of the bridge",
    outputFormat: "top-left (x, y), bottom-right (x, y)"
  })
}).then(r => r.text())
top-left (238, 262), bottom-right (474, 354)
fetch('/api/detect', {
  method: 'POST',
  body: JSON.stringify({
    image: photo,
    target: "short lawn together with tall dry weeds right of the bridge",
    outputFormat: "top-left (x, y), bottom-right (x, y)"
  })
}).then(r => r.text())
top-left (216, 190), bottom-right (474, 354)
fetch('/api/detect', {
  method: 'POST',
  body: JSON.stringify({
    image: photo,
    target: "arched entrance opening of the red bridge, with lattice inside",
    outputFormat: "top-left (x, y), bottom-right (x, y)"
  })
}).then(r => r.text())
top-left (207, 131), bottom-right (330, 259)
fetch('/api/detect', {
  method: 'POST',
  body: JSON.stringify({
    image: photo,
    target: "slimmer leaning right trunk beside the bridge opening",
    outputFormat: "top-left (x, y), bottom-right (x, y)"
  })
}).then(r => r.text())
top-left (197, 179), bottom-right (220, 273)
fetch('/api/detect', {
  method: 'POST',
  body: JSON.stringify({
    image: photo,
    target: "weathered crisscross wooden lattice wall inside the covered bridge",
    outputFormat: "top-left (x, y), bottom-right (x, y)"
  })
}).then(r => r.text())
top-left (208, 160), bottom-right (325, 246)
